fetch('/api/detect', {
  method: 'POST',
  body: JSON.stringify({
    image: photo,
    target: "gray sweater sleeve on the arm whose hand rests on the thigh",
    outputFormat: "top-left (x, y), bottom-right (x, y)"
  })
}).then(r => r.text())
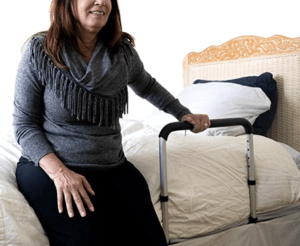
top-left (13, 39), bottom-right (53, 166)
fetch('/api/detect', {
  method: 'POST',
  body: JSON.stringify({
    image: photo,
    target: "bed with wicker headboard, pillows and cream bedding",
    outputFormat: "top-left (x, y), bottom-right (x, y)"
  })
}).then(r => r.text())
top-left (0, 35), bottom-right (300, 246)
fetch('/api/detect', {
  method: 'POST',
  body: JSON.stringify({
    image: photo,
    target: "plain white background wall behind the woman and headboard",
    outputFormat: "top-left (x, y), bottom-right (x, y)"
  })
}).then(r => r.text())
top-left (0, 0), bottom-right (300, 129)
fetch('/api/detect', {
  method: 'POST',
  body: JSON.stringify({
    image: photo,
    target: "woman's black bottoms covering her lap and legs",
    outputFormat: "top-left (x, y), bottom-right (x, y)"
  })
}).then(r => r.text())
top-left (16, 157), bottom-right (167, 246)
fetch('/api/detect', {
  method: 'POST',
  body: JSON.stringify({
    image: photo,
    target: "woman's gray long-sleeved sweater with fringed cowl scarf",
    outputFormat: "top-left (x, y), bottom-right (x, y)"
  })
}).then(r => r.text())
top-left (13, 33), bottom-right (191, 170)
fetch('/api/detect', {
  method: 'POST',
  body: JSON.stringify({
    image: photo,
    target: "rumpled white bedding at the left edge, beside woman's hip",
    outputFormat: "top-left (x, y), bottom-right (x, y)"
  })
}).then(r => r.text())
top-left (0, 134), bottom-right (49, 246)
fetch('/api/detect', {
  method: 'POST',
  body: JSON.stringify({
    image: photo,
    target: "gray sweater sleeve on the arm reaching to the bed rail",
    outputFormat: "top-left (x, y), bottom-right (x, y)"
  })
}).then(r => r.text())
top-left (128, 43), bottom-right (191, 121)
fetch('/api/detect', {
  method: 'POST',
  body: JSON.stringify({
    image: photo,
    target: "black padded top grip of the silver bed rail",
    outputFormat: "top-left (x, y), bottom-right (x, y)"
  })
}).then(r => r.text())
top-left (159, 118), bottom-right (253, 141)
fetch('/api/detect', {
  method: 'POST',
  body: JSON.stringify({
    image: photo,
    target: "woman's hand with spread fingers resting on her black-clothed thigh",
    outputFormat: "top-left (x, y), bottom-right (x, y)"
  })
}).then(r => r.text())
top-left (39, 153), bottom-right (95, 217)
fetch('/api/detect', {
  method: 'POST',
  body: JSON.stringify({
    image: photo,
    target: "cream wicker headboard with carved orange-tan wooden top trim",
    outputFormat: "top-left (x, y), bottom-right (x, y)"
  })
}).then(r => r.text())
top-left (183, 35), bottom-right (300, 151)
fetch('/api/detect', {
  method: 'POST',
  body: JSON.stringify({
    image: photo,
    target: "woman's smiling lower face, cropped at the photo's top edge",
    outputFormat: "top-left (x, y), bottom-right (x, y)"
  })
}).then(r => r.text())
top-left (72, 0), bottom-right (112, 33)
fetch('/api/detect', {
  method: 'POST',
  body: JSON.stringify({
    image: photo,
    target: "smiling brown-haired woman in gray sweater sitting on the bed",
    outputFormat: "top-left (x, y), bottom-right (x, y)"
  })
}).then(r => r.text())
top-left (13, 0), bottom-right (210, 246)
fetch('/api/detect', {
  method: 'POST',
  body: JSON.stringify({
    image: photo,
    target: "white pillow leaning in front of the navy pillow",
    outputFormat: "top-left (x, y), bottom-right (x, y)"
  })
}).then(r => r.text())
top-left (146, 82), bottom-right (271, 136)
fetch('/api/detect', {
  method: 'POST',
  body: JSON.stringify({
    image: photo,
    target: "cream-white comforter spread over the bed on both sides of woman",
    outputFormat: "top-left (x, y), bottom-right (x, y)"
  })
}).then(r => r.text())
top-left (0, 119), bottom-right (299, 246)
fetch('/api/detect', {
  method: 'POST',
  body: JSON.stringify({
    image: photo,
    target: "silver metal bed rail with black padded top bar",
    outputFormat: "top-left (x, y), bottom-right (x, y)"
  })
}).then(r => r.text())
top-left (159, 118), bottom-right (257, 243)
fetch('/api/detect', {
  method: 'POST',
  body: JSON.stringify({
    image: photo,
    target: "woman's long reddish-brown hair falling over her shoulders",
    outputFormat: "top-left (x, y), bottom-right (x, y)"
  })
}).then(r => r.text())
top-left (25, 0), bottom-right (135, 69)
